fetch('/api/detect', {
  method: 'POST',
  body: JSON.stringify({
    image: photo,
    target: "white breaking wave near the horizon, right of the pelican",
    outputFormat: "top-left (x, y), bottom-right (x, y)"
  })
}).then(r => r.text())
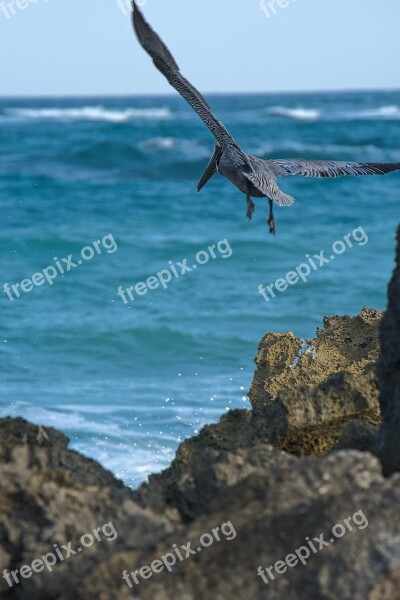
top-left (266, 104), bottom-right (400, 121)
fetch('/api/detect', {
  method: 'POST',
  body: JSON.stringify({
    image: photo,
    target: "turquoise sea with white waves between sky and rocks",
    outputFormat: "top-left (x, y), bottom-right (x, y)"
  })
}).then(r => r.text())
top-left (0, 92), bottom-right (400, 485)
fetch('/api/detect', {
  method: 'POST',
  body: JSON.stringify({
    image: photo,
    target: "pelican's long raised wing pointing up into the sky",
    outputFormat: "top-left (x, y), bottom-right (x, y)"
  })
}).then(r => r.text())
top-left (132, 1), bottom-right (239, 148)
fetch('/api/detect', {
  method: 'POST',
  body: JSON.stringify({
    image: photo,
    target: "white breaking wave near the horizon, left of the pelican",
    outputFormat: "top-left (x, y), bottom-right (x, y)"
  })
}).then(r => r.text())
top-left (4, 106), bottom-right (172, 123)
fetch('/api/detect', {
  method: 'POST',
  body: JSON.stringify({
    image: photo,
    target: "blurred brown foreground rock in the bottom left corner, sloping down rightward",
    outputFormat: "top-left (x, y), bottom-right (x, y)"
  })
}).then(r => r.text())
top-left (0, 418), bottom-right (177, 600)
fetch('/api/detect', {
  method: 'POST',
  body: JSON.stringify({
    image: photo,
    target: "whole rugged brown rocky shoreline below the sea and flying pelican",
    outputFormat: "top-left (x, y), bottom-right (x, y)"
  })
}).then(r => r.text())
top-left (0, 228), bottom-right (400, 600)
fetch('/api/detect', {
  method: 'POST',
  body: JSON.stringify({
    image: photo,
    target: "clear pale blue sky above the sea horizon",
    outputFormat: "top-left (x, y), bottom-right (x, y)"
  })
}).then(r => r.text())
top-left (0, 0), bottom-right (400, 96)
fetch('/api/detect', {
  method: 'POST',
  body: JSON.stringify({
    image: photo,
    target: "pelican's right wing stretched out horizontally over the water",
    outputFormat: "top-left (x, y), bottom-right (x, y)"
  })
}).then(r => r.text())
top-left (268, 158), bottom-right (400, 178)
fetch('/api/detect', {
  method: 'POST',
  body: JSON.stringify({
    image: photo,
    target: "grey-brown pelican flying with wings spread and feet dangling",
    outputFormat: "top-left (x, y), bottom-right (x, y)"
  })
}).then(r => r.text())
top-left (132, 0), bottom-right (400, 234)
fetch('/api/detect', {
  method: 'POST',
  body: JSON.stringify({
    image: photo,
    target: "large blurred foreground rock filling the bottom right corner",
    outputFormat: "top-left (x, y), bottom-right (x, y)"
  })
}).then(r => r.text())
top-left (79, 448), bottom-right (400, 600)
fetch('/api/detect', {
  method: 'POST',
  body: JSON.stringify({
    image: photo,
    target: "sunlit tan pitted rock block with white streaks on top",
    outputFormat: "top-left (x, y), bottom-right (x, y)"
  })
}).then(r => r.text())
top-left (249, 308), bottom-right (382, 456)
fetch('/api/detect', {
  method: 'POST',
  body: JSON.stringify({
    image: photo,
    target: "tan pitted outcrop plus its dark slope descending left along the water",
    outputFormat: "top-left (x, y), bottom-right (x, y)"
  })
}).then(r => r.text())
top-left (137, 308), bottom-right (382, 508)
